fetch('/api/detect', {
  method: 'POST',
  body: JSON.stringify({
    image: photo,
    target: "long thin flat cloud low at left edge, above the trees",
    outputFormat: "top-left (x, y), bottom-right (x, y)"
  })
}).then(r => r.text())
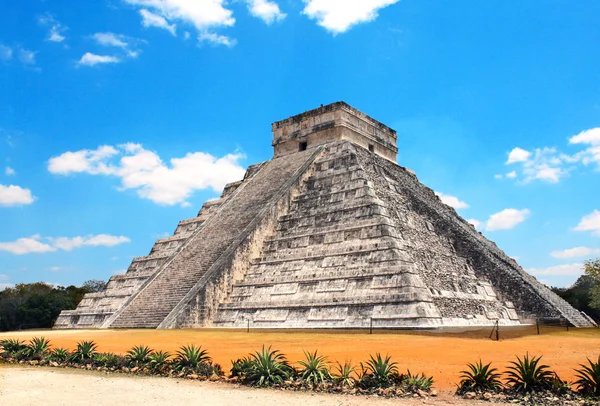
top-left (0, 234), bottom-right (131, 255)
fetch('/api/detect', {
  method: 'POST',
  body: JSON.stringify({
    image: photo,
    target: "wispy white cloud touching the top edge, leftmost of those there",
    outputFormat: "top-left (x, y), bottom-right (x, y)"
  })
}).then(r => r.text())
top-left (125, 0), bottom-right (235, 46)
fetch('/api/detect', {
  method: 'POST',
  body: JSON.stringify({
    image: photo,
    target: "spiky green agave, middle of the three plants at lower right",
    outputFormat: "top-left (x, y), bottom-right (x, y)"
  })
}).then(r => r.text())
top-left (506, 354), bottom-right (556, 392)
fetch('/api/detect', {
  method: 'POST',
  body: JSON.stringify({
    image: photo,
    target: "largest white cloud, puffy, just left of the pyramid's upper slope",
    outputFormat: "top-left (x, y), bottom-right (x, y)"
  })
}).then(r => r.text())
top-left (48, 143), bottom-right (244, 205)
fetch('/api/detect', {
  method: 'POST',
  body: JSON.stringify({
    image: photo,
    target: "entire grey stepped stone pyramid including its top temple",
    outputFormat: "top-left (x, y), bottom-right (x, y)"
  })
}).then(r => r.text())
top-left (55, 102), bottom-right (593, 328)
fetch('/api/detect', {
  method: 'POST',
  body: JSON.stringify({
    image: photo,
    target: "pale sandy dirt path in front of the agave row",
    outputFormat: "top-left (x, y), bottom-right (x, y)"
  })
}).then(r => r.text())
top-left (0, 366), bottom-right (496, 406)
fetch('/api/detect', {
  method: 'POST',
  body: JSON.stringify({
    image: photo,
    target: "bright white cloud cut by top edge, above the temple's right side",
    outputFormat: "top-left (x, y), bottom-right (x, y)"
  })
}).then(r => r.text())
top-left (302, 0), bottom-right (398, 34)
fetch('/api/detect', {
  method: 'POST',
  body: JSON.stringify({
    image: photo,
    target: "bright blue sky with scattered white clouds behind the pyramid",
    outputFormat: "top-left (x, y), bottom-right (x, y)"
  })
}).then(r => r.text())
top-left (0, 0), bottom-right (600, 287)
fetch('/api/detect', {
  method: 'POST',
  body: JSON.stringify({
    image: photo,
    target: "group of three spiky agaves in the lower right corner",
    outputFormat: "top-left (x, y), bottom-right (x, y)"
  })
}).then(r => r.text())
top-left (457, 354), bottom-right (600, 397)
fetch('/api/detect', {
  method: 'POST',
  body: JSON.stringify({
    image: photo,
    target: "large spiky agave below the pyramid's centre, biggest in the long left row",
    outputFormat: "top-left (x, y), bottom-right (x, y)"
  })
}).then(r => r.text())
top-left (243, 345), bottom-right (294, 386)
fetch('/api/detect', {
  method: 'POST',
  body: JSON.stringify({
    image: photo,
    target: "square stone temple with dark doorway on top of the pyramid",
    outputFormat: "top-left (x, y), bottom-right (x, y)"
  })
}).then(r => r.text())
top-left (272, 101), bottom-right (398, 162)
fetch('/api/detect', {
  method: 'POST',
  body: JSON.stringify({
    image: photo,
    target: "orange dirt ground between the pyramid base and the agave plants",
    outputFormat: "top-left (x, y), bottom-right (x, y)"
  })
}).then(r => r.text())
top-left (0, 327), bottom-right (600, 390)
